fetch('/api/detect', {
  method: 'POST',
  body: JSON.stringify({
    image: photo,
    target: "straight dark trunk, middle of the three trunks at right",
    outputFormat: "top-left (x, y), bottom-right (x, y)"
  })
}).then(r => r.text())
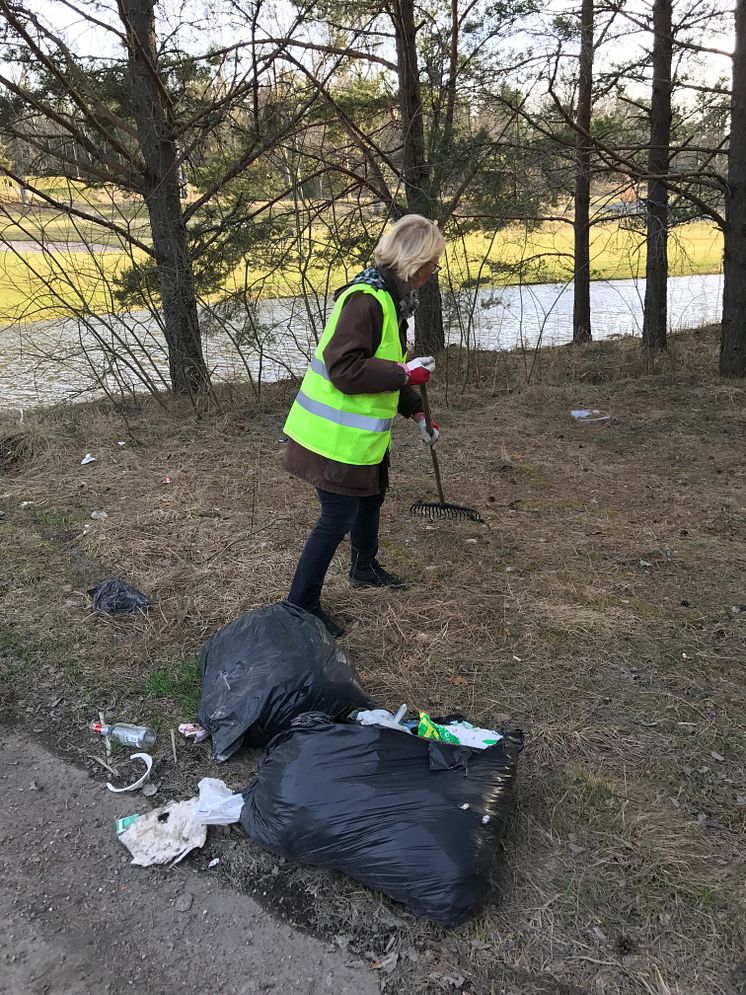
top-left (642, 0), bottom-right (673, 350)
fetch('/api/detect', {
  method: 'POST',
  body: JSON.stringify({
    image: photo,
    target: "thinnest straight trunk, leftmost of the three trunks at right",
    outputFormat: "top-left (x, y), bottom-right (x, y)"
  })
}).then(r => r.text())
top-left (572, 0), bottom-right (593, 342)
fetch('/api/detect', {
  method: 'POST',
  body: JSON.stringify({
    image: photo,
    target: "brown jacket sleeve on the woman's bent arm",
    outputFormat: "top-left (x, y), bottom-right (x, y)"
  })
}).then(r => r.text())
top-left (324, 292), bottom-right (406, 394)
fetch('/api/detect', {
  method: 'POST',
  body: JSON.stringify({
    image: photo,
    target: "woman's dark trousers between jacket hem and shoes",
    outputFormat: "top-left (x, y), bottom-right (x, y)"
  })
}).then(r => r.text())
top-left (288, 488), bottom-right (386, 611)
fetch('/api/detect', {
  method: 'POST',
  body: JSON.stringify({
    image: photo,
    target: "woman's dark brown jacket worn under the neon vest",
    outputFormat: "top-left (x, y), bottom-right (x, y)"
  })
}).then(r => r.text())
top-left (285, 269), bottom-right (422, 497)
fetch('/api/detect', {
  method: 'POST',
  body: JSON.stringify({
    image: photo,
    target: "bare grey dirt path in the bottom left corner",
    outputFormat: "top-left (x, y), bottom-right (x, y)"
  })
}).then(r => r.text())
top-left (0, 733), bottom-right (378, 995)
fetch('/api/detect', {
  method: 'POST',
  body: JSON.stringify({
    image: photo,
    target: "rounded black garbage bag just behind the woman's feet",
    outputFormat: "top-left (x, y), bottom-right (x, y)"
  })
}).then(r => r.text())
top-left (197, 602), bottom-right (371, 762)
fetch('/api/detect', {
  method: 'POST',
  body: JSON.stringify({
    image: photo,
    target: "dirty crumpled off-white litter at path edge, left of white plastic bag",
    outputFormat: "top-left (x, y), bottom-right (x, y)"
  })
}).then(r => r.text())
top-left (119, 798), bottom-right (207, 867)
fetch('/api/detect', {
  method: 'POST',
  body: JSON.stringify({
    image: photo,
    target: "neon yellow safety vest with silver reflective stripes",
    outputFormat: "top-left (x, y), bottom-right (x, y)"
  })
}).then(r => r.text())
top-left (285, 284), bottom-right (404, 466)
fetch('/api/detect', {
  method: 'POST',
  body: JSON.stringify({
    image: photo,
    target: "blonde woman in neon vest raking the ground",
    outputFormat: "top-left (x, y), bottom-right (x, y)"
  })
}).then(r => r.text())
top-left (285, 214), bottom-right (445, 638)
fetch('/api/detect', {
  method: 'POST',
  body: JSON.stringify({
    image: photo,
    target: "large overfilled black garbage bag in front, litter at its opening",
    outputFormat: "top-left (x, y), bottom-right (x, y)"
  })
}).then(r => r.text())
top-left (241, 714), bottom-right (522, 926)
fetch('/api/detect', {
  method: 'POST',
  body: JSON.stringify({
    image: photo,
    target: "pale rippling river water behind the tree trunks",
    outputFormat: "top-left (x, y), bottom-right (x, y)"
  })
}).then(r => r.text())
top-left (0, 275), bottom-right (723, 408)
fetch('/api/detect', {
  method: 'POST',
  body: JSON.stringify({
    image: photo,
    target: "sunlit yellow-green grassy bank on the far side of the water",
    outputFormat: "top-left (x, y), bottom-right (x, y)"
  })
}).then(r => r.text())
top-left (0, 189), bottom-right (723, 324)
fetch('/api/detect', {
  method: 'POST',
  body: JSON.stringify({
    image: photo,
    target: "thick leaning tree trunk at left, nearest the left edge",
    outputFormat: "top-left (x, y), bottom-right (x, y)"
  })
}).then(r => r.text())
top-left (120, 0), bottom-right (210, 397)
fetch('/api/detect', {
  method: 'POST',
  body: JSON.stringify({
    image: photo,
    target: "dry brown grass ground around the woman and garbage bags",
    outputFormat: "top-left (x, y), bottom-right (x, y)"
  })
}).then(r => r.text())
top-left (0, 330), bottom-right (746, 995)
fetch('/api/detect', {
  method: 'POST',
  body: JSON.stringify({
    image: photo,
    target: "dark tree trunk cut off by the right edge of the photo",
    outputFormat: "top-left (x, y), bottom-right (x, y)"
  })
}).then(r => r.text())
top-left (720, 0), bottom-right (746, 377)
